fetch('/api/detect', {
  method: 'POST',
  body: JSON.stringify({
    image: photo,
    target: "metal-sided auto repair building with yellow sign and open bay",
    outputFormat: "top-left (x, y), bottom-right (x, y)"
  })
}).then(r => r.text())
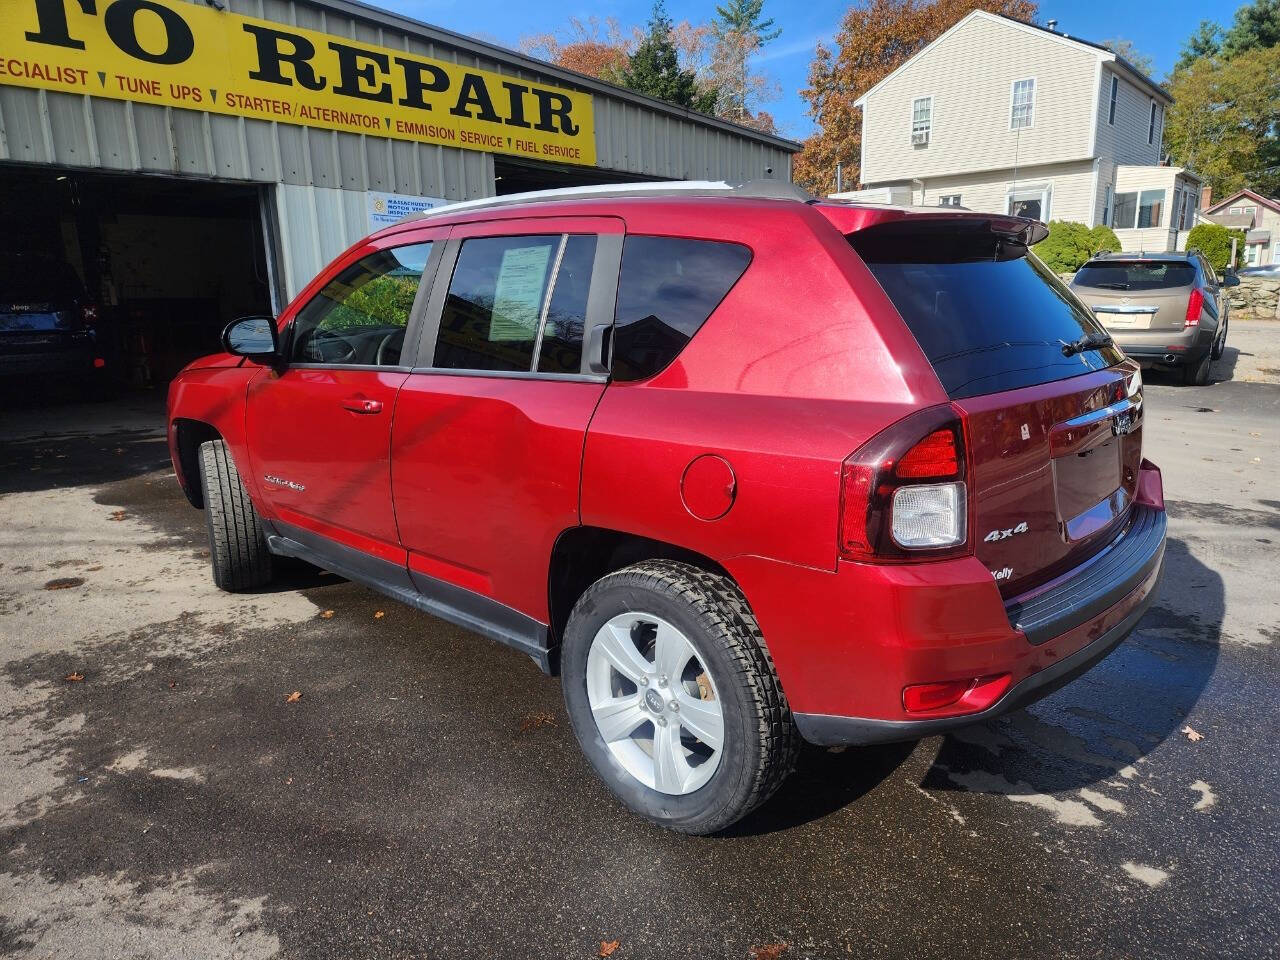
top-left (0, 0), bottom-right (799, 383)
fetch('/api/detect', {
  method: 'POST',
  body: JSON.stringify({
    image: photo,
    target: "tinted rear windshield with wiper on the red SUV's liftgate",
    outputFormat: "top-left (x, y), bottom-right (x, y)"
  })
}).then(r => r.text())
top-left (849, 219), bottom-right (1123, 399)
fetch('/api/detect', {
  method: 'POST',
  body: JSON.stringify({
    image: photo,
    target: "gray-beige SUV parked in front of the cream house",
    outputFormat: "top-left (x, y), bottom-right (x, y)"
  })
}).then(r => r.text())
top-left (1071, 250), bottom-right (1239, 385)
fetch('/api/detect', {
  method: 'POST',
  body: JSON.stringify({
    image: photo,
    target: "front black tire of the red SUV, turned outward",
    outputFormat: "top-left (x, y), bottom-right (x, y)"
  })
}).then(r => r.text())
top-left (200, 440), bottom-right (271, 591)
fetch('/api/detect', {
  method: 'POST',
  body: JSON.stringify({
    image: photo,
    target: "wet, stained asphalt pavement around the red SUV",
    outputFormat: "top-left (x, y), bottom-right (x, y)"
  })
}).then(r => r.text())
top-left (0, 323), bottom-right (1280, 960)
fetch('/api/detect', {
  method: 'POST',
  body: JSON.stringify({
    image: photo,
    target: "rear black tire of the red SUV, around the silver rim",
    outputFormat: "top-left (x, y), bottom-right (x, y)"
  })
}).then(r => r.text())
top-left (561, 561), bottom-right (800, 835)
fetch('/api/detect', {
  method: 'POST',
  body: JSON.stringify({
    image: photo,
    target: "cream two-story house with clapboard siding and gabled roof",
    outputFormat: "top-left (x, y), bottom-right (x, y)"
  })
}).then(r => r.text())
top-left (841, 10), bottom-right (1201, 250)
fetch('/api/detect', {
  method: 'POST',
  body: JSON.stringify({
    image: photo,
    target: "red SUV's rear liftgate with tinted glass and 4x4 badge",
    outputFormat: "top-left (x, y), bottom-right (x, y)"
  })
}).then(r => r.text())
top-left (850, 218), bottom-right (1142, 595)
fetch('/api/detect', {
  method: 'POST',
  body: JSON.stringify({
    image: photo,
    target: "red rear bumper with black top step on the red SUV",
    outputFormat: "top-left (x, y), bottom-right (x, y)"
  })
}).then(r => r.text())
top-left (730, 488), bottom-right (1166, 745)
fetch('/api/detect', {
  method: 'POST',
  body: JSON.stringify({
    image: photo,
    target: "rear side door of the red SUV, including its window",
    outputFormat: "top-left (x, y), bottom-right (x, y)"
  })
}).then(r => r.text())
top-left (392, 218), bottom-right (623, 623)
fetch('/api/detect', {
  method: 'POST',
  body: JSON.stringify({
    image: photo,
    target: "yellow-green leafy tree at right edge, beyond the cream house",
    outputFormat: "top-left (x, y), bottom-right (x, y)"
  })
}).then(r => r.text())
top-left (1165, 45), bottom-right (1280, 196)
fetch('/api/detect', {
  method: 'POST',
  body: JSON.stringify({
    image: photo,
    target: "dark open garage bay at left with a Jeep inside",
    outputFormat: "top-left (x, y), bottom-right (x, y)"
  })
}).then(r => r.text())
top-left (0, 165), bottom-right (271, 392)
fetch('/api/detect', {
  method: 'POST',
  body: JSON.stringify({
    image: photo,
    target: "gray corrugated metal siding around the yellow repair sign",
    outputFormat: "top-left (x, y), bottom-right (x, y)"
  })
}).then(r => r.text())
top-left (0, 0), bottom-right (791, 298)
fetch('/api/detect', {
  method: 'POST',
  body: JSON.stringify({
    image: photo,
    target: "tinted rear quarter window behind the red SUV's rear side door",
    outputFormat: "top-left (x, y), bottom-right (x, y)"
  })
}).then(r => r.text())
top-left (613, 237), bottom-right (751, 380)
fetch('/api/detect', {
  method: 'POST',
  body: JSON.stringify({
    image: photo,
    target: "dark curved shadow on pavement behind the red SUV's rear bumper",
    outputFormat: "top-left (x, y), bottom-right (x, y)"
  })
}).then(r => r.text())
top-left (922, 538), bottom-right (1225, 795)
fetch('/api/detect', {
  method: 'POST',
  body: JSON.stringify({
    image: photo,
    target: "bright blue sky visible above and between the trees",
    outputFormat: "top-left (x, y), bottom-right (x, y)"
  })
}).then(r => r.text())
top-left (366, 0), bottom-right (1239, 140)
